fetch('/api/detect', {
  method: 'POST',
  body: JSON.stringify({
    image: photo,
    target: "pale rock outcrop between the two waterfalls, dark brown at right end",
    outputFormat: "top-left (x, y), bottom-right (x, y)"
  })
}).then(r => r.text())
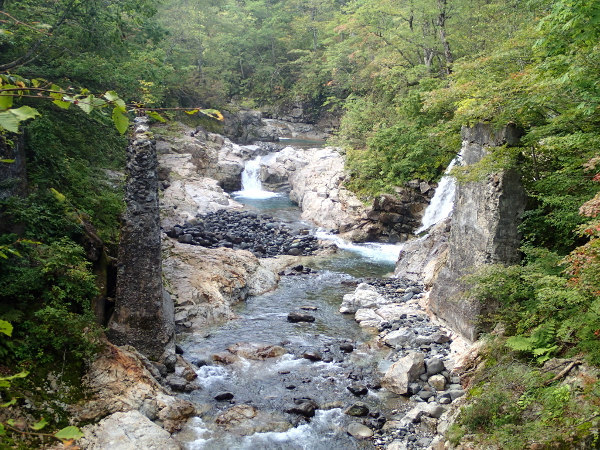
top-left (260, 147), bottom-right (434, 242)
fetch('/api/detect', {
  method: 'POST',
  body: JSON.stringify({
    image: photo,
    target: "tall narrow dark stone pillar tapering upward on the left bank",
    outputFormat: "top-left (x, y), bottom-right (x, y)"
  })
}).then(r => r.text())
top-left (108, 118), bottom-right (175, 367)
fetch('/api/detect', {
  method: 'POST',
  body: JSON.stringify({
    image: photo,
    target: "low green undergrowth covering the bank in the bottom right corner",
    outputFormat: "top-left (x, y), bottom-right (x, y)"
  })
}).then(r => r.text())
top-left (449, 338), bottom-right (600, 449)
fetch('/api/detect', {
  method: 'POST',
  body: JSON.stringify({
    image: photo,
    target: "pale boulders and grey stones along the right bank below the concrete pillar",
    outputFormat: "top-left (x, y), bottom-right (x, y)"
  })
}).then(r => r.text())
top-left (340, 278), bottom-right (465, 449)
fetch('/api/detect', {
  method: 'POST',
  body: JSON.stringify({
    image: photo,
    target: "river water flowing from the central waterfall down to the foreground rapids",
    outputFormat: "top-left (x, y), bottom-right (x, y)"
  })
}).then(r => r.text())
top-left (180, 155), bottom-right (405, 450)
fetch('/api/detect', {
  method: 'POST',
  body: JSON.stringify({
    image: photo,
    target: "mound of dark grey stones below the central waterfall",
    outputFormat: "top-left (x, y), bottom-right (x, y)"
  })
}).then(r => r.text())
top-left (167, 210), bottom-right (320, 258)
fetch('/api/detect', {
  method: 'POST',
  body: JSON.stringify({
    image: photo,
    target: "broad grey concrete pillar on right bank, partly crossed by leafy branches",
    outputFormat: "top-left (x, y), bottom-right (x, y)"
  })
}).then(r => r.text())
top-left (430, 124), bottom-right (525, 340)
